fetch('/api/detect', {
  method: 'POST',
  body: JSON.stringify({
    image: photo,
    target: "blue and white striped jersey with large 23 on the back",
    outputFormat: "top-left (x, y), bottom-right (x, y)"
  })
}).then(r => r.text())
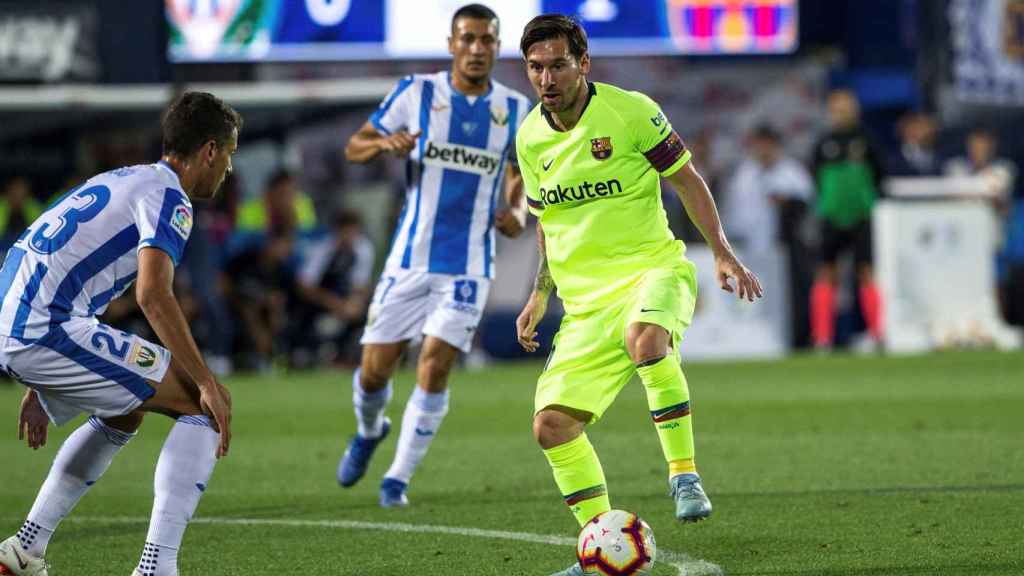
top-left (0, 162), bottom-right (193, 342)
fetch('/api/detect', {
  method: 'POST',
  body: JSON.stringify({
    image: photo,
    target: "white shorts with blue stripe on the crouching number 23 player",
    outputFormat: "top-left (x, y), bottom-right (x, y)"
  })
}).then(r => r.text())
top-left (0, 318), bottom-right (171, 426)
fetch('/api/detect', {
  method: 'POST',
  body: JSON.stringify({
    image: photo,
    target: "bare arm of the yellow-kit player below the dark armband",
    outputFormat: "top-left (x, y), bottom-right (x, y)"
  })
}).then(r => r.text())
top-left (668, 162), bottom-right (763, 302)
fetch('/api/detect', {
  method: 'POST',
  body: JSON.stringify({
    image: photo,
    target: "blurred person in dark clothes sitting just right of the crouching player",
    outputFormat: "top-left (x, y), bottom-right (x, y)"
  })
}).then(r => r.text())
top-left (221, 227), bottom-right (295, 371)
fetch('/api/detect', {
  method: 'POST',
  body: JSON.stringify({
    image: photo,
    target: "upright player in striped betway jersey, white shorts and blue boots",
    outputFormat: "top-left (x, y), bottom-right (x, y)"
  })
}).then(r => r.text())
top-left (338, 4), bottom-right (529, 507)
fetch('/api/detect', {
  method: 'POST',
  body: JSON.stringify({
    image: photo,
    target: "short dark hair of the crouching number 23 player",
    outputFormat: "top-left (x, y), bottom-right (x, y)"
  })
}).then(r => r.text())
top-left (161, 92), bottom-right (242, 157)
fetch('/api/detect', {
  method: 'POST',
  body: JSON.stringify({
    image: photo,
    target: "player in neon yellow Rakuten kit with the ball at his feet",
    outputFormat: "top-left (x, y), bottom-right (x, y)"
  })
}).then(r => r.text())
top-left (516, 14), bottom-right (762, 576)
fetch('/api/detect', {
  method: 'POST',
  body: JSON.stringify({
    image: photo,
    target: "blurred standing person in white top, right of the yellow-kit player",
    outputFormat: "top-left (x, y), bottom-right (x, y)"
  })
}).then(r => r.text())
top-left (723, 124), bottom-right (814, 347)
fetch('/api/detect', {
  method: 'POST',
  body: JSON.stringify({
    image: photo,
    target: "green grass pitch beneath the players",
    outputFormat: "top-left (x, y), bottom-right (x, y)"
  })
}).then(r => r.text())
top-left (0, 353), bottom-right (1024, 576)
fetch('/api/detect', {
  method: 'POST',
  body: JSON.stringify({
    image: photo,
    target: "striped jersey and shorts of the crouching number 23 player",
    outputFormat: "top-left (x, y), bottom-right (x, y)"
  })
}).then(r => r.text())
top-left (0, 163), bottom-right (193, 424)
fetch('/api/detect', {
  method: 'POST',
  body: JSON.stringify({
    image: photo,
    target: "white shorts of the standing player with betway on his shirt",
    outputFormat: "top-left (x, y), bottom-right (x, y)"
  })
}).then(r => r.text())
top-left (359, 270), bottom-right (490, 353)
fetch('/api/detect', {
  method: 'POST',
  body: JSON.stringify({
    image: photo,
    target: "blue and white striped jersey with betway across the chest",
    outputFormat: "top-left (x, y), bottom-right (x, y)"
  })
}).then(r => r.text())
top-left (370, 72), bottom-right (529, 278)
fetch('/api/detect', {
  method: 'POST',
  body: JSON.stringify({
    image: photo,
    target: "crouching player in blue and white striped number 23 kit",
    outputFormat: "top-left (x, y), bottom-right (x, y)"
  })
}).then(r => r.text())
top-left (0, 92), bottom-right (242, 576)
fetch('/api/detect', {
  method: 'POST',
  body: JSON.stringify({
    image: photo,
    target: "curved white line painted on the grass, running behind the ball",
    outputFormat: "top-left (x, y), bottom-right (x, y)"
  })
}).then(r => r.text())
top-left (65, 516), bottom-right (725, 576)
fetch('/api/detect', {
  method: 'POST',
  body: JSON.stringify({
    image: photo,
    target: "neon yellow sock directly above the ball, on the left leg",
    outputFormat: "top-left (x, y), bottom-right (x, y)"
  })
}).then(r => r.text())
top-left (544, 434), bottom-right (611, 526)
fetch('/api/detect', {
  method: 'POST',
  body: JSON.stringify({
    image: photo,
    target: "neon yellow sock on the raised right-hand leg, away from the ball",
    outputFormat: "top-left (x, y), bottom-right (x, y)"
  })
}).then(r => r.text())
top-left (637, 354), bottom-right (696, 478)
